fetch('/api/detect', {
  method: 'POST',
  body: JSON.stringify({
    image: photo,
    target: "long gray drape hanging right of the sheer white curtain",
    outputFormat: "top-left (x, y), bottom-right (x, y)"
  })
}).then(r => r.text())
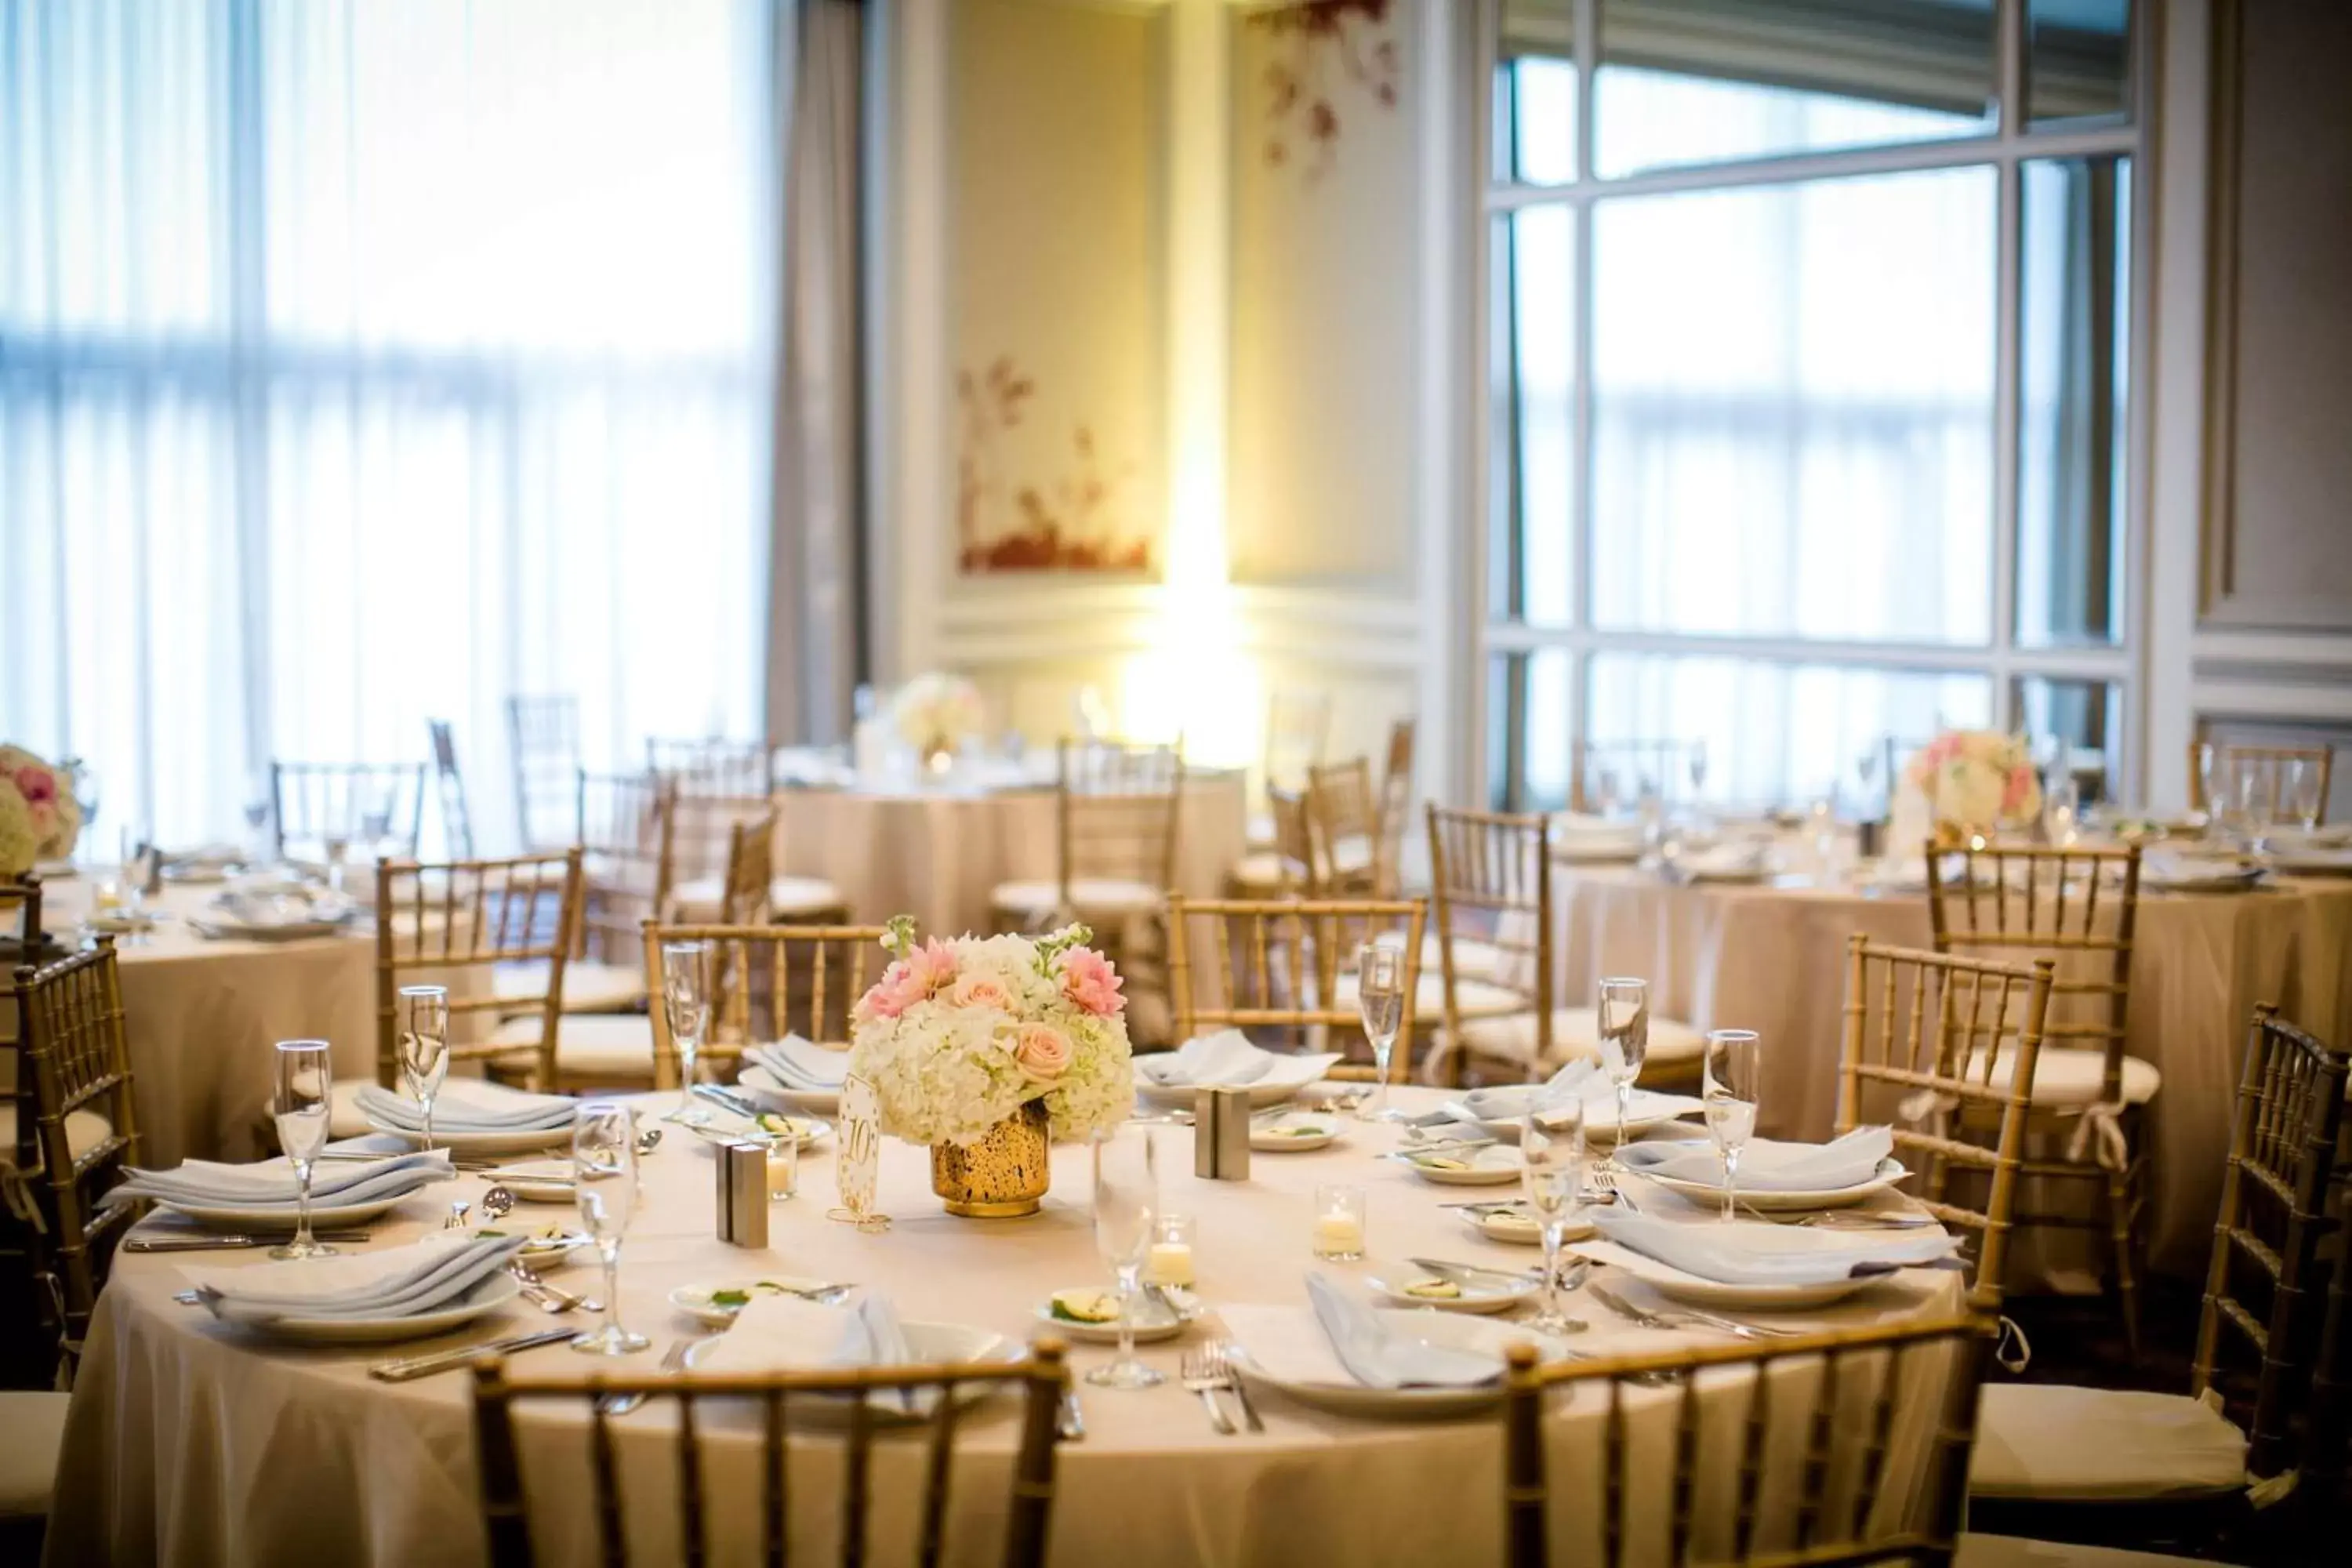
top-left (767, 0), bottom-right (866, 741)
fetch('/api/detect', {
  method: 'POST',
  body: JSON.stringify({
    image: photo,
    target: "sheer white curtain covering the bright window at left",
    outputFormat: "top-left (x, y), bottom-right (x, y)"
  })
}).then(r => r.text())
top-left (0, 0), bottom-right (788, 846)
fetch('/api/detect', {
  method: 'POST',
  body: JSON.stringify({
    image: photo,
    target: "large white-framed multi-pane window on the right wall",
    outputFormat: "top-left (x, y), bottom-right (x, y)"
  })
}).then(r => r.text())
top-left (1484, 0), bottom-right (2138, 806)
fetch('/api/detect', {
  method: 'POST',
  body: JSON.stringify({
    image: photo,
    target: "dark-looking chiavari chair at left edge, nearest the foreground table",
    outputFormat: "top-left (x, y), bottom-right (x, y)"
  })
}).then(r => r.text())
top-left (0, 935), bottom-right (141, 1356)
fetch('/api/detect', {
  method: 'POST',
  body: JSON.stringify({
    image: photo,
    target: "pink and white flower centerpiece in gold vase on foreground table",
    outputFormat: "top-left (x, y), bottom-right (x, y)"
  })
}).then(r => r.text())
top-left (849, 914), bottom-right (1136, 1218)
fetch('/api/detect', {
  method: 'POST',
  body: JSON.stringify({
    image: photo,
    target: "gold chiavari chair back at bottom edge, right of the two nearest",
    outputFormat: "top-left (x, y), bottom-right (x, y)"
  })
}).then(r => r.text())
top-left (1503, 1314), bottom-right (1990, 1568)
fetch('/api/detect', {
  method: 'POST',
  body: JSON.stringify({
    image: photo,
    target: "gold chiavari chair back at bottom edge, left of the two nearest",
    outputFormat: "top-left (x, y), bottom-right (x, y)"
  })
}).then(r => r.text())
top-left (473, 1338), bottom-right (1070, 1568)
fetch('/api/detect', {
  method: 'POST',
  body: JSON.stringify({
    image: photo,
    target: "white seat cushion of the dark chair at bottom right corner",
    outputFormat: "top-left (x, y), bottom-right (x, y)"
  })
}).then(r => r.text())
top-left (1969, 1382), bottom-right (2246, 1502)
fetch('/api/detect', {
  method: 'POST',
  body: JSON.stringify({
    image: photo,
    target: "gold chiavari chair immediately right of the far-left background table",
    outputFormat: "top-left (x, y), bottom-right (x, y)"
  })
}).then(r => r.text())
top-left (374, 848), bottom-right (597, 1091)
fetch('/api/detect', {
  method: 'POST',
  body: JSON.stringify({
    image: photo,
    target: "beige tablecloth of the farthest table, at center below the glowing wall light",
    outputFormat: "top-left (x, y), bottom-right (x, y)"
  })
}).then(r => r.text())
top-left (776, 769), bottom-right (1247, 935)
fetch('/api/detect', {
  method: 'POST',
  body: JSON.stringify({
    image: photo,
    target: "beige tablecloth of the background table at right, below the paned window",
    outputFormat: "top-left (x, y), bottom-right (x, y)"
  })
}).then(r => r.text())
top-left (1552, 862), bottom-right (2352, 1288)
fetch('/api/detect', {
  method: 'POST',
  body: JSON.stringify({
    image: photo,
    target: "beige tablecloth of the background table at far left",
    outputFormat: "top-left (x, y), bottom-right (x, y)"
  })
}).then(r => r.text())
top-left (42, 872), bottom-right (376, 1166)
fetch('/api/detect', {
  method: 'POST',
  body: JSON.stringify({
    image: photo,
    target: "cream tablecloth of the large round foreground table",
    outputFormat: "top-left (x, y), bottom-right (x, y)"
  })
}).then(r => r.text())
top-left (47, 1091), bottom-right (1962, 1568)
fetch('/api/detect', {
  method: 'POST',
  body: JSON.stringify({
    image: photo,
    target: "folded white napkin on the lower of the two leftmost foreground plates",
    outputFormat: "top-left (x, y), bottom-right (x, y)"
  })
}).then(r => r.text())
top-left (186, 1232), bottom-right (524, 1323)
